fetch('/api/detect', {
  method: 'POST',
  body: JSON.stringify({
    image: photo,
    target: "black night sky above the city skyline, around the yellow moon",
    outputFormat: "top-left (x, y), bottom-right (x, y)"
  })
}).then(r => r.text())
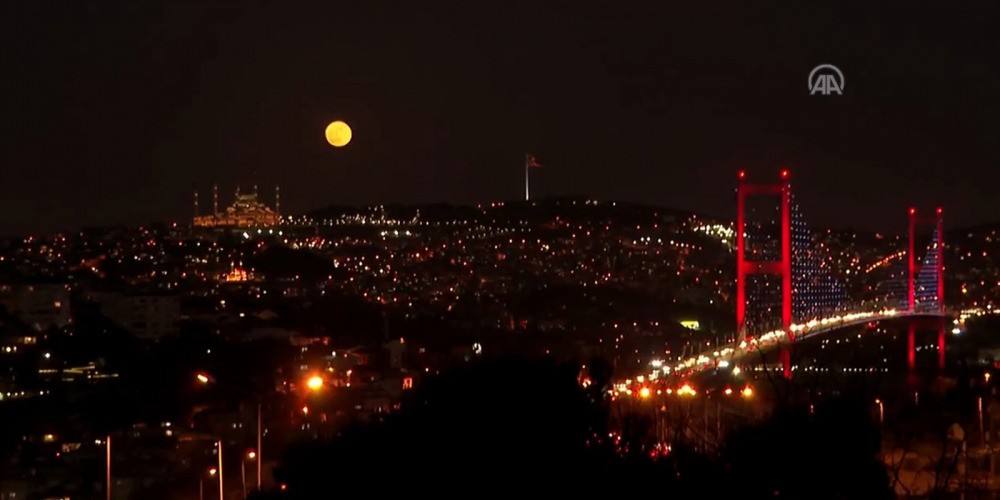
top-left (0, 0), bottom-right (1000, 234)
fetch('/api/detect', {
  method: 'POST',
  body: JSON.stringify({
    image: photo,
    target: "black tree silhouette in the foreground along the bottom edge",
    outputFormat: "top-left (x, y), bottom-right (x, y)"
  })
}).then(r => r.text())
top-left (258, 359), bottom-right (892, 499)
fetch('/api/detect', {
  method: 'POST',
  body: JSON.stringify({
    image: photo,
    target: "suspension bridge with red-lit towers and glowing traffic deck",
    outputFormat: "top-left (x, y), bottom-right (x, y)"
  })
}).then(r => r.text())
top-left (670, 170), bottom-right (948, 378)
